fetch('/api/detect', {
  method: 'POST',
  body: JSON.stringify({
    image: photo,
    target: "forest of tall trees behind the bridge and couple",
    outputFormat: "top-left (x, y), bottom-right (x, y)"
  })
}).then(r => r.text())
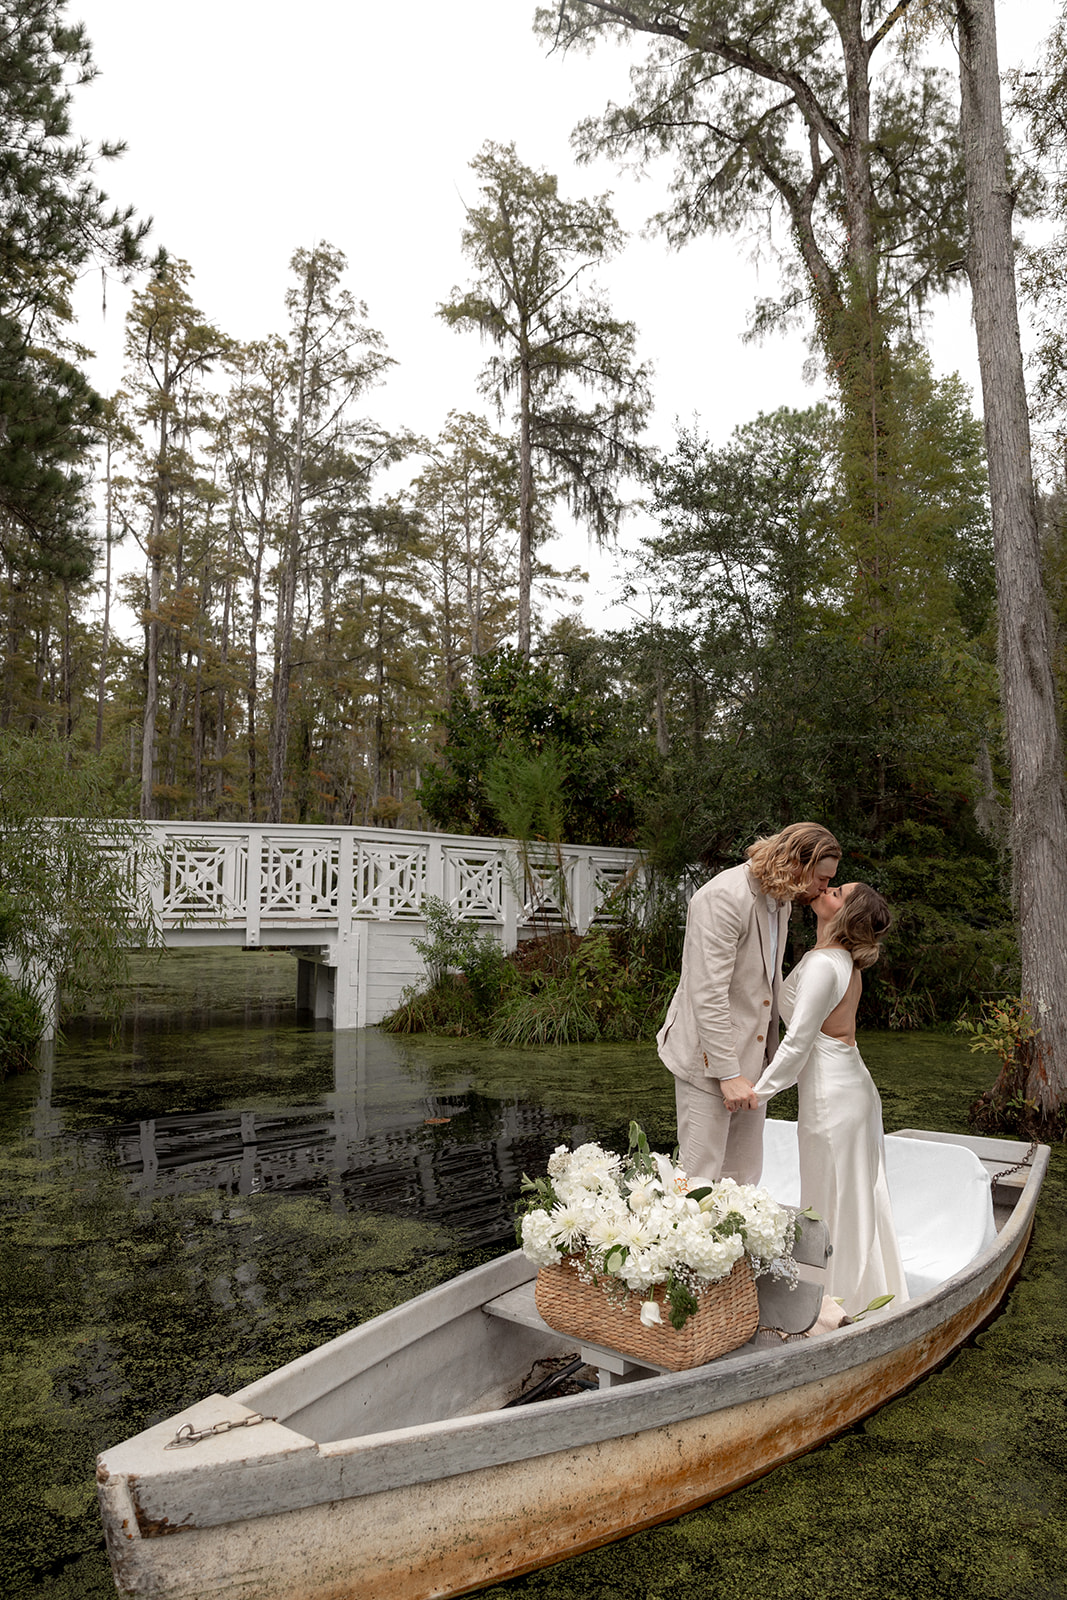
top-left (0, 0), bottom-right (1067, 1026)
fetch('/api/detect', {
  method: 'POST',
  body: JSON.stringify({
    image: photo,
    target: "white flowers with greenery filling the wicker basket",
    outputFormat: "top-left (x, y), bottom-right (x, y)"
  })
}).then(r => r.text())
top-left (518, 1122), bottom-right (798, 1328)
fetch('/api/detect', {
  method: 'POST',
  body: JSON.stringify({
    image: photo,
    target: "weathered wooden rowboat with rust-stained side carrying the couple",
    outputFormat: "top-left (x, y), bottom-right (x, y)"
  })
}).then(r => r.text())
top-left (98, 1125), bottom-right (1048, 1600)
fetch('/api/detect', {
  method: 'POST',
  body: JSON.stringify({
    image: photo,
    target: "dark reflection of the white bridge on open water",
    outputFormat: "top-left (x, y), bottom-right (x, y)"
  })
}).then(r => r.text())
top-left (58, 1019), bottom-right (598, 1246)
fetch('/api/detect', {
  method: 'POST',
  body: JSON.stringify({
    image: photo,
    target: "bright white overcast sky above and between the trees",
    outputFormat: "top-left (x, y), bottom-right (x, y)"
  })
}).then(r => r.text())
top-left (67, 0), bottom-right (1056, 626)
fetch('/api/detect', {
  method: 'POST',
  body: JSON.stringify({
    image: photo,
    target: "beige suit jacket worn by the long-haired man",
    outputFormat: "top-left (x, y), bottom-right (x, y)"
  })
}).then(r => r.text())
top-left (656, 866), bottom-right (792, 1088)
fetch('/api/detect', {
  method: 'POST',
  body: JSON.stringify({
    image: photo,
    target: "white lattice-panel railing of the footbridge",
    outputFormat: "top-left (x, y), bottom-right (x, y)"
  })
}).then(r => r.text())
top-left (131, 822), bottom-right (640, 946)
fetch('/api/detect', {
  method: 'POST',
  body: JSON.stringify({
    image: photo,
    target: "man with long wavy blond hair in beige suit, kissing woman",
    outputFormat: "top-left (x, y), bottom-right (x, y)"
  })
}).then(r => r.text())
top-left (656, 822), bottom-right (841, 1184)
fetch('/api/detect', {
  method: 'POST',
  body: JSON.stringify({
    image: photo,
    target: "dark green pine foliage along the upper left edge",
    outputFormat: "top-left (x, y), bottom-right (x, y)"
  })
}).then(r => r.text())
top-left (0, 0), bottom-right (147, 604)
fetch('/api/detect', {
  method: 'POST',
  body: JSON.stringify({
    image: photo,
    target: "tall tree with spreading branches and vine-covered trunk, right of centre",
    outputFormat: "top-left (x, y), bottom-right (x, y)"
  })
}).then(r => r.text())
top-left (536, 0), bottom-right (965, 608)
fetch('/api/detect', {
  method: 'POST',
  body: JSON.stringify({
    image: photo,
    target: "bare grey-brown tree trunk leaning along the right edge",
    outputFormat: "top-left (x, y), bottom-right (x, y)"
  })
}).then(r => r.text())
top-left (958, 0), bottom-right (1067, 1117)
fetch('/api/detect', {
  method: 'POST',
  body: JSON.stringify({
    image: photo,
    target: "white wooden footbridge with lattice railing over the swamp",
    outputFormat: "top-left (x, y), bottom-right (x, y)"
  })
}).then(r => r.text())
top-left (122, 822), bottom-right (640, 1029)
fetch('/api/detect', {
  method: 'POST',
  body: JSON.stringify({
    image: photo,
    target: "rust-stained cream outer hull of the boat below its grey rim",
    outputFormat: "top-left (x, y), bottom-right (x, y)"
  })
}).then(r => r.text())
top-left (101, 1206), bottom-right (1032, 1600)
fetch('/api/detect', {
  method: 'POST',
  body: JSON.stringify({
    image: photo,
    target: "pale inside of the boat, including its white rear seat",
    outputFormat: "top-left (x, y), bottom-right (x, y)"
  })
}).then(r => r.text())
top-left (232, 1122), bottom-right (1027, 1443)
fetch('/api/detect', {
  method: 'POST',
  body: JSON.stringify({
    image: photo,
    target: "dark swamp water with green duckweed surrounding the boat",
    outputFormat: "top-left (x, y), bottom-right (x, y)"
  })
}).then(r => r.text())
top-left (0, 952), bottom-right (1067, 1600)
